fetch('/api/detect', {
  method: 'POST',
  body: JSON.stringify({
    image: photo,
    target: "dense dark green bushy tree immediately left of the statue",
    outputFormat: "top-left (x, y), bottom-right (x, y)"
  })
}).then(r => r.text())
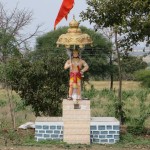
top-left (2, 56), bottom-right (68, 116)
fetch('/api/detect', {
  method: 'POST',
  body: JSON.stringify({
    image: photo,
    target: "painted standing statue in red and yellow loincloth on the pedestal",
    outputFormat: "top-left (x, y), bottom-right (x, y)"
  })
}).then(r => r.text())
top-left (64, 50), bottom-right (89, 100)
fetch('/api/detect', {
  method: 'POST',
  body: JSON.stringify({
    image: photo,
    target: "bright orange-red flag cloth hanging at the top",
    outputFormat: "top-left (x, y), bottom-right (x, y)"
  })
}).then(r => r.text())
top-left (54, 0), bottom-right (74, 29)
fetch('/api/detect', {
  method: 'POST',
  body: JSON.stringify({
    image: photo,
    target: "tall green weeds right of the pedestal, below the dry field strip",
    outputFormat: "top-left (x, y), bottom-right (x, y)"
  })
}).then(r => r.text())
top-left (85, 89), bottom-right (150, 129)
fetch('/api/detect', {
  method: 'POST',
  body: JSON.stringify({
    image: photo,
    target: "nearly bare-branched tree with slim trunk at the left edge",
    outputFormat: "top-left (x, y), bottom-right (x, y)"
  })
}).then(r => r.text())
top-left (0, 3), bottom-right (39, 128)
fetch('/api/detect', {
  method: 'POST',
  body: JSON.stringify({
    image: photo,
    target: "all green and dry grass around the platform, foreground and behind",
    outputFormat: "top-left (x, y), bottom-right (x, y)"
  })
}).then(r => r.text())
top-left (0, 81), bottom-right (150, 150)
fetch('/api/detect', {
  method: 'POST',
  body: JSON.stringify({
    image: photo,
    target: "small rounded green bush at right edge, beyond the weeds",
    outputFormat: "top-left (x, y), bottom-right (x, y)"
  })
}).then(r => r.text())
top-left (134, 69), bottom-right (150, 88)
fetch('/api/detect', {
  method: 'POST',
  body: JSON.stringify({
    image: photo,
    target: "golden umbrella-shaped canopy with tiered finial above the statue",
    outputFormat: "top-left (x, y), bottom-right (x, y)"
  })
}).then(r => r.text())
top-left (56, 18), bottom-right (93, 49)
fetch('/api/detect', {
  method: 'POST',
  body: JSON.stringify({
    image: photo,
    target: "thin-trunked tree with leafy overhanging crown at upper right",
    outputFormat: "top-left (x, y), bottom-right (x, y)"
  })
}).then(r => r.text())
top-left (81, 0), bottom-right (150, 124)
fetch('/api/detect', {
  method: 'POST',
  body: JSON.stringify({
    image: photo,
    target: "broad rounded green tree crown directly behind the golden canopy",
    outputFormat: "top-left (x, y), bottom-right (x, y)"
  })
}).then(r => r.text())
top-left (34, 26), bottom-right (111, 80)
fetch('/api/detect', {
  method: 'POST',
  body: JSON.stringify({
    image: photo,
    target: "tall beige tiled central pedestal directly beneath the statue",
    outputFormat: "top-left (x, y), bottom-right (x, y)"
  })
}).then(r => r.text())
top-left (63, 99), bottom-right (91, 144)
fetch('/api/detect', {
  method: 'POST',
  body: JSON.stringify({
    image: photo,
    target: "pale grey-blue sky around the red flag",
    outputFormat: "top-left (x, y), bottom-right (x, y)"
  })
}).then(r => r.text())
top-left (1, 0), bottom-right (93, 45)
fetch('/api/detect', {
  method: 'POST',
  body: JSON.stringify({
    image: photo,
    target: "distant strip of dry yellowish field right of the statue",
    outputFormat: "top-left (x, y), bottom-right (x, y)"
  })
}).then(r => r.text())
top-left (86, 81), bottom-right (141, 90)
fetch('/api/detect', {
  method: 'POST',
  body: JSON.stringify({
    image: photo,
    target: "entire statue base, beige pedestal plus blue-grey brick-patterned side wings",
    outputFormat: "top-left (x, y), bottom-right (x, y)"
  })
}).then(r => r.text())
top-left (35, 100), bottom-right (120, 144)
